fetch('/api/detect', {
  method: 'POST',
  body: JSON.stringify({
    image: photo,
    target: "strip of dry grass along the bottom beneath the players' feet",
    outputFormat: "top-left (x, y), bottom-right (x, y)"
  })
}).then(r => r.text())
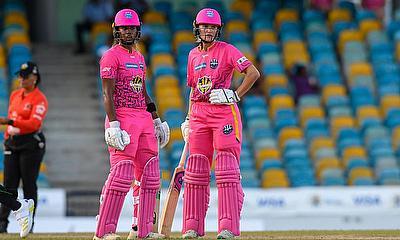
top-left (0, 230), bottom-right (400, 240)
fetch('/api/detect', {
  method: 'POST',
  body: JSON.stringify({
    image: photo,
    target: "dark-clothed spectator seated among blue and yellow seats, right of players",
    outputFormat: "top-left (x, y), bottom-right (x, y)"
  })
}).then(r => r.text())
top-left (289, 63), bottom-right (319, 102)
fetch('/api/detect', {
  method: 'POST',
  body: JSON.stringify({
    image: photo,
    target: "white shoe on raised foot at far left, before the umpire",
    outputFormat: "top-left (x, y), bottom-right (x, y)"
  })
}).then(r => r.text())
top-left (12, 199), bottom-right (35, 238)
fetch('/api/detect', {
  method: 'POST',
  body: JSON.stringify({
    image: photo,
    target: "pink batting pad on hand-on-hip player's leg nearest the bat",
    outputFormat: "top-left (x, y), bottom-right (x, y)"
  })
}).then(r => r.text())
top-left (182, 154), bottom-right (210, 236)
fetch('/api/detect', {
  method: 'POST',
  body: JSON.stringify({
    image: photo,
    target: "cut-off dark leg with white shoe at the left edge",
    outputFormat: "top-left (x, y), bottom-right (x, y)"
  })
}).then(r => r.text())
top-left (0, 185), bottom-right (35, 238)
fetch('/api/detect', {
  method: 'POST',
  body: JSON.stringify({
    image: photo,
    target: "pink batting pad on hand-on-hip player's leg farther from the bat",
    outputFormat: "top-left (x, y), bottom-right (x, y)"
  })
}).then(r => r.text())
top-left (215, 152), bottom-right (244, 236)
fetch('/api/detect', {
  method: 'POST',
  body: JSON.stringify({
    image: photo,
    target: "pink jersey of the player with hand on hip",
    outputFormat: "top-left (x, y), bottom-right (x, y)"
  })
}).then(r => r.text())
top-left (187, 41), bottom-right (252, 102)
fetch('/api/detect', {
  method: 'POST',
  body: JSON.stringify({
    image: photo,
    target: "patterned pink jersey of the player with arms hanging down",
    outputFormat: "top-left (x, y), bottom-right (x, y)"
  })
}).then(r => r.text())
top-left (100, 45), bottom-right (146, 109)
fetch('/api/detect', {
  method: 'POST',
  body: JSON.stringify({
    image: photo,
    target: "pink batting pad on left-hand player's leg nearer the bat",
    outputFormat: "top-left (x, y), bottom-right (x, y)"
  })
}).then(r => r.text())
top-left (138, 157), bottom-right (160, 238)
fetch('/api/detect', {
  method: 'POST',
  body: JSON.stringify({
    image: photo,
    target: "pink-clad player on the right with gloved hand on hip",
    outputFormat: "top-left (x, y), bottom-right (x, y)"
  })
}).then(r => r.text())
top-left (181, 8), bottom-right (260, 239)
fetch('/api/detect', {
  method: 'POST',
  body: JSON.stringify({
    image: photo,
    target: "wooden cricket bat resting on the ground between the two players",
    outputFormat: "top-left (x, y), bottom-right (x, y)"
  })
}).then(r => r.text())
top-left (160, 143), bottom-right (187, 236)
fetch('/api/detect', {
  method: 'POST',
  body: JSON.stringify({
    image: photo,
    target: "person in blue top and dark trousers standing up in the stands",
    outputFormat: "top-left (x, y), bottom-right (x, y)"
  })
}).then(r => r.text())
top-left (75, 0), bottom-right (114, 53)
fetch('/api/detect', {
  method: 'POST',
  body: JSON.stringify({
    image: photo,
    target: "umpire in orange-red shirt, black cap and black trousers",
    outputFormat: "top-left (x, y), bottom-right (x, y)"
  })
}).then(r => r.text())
top-left (0, 62), bottom-right (48, 233)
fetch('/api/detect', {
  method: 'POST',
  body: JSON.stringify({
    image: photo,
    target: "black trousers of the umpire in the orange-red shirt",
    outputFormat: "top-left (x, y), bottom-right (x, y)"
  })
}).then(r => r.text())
top-left (0, 133), bottom-right (46, 226)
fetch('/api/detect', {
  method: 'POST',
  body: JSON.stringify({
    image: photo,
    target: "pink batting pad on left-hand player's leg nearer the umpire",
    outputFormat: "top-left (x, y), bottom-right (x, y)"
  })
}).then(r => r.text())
top-left (96, 160), bottom-right (134, 237)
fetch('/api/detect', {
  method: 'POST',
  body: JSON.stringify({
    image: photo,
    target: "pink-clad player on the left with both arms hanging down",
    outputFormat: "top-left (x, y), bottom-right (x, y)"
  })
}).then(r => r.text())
top-left (93, 9), bottom-right (169, 240)
